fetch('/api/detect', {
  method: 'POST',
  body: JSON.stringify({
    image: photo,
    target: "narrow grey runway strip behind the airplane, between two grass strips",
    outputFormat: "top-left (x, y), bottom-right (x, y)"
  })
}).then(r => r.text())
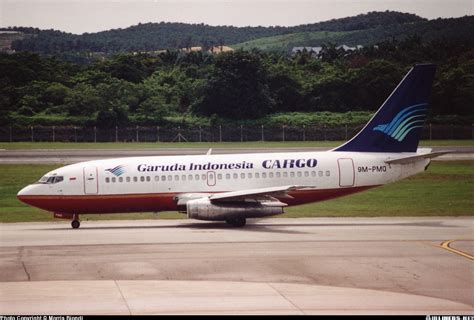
top-left (0, 146), bottom-right (474, 164)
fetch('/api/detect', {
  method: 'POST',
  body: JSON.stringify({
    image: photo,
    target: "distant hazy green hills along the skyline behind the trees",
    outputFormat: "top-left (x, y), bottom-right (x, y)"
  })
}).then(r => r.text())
top-left (1, 11), bottom-right (425, 54)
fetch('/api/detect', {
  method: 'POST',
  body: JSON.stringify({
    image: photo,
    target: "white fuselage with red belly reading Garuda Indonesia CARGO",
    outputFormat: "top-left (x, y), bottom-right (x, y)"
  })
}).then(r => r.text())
top-left (18, 151), bottom-right (429, 213)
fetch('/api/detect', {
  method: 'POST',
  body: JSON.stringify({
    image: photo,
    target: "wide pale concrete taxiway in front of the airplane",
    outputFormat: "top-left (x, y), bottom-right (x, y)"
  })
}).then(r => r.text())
top-left (0, 217), bottom-right (474, 314)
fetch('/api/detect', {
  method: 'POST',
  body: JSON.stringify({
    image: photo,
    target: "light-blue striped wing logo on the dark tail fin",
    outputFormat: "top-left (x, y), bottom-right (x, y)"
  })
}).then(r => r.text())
top-left (372, 103), bottom-right (428, 142)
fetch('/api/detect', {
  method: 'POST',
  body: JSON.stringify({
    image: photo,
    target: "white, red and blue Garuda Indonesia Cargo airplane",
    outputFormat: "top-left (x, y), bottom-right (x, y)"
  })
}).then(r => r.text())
top-left (17, 64), bottom-right (449, 229)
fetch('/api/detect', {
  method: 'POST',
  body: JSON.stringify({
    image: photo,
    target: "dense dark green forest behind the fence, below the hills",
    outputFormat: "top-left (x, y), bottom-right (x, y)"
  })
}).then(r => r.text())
top-left (0, 36), bottom-right (474, 127)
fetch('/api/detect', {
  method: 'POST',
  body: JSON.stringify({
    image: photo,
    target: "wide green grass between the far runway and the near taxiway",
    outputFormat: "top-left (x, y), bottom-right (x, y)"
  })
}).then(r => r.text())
top-left (0, 161), bottom-right (474, 222)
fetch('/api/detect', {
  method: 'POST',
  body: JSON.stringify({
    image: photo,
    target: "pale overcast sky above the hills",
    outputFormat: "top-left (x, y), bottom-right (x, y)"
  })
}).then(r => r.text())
top-left (0, 0), bottom-right (474, 34)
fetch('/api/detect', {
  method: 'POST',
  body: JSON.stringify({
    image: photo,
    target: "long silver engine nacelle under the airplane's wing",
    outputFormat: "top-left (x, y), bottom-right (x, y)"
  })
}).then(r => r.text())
top-left (186, 198), bottom-right (283, 221)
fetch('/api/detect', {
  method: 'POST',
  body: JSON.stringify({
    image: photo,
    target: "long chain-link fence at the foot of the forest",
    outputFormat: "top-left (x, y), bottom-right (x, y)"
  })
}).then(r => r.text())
top-left (0, 124), bottom-right (474, 142)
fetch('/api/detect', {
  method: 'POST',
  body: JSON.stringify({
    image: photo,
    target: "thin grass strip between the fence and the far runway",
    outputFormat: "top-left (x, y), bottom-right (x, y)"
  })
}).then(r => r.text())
top-left (0, 140), bottom-right (474, 150)
